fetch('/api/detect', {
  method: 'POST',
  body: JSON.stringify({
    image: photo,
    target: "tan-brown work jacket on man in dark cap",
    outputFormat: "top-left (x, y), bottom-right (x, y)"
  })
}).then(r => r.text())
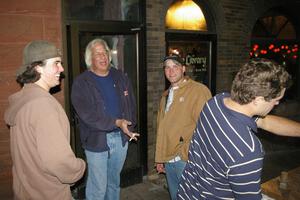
top-left (155, 78), bottom-right (211, 163)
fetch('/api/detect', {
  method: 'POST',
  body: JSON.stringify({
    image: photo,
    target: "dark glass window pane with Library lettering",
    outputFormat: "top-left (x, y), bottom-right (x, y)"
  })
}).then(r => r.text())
top-left (166, 33), bottom-right (216, 94)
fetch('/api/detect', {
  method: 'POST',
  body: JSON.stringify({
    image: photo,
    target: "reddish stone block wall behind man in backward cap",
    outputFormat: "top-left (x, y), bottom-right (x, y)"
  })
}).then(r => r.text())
top-left (0, 0), bottom-right (64, 187)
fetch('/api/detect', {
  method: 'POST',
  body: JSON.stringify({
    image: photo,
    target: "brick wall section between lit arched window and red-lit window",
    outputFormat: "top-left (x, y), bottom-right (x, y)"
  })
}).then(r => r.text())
top-left (216, 0), bottom-right (255, 92)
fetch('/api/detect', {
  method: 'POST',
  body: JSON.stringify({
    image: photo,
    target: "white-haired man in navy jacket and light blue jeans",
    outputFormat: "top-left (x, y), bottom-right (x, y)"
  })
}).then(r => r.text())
top-left (71, 39), bottom-right (139, 200)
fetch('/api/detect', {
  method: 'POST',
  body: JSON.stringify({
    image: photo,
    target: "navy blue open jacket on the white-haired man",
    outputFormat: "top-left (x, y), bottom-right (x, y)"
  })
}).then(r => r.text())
top-left (71, 67), bottom-right (136, 152)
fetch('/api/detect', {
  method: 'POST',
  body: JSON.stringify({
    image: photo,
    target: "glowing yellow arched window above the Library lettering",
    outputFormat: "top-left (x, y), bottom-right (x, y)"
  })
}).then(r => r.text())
top-left (166, 0), bottom-right (207, 31)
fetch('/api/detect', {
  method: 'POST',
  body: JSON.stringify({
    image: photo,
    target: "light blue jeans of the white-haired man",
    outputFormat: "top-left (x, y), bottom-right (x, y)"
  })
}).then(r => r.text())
top-left (85, 132), bottom-right (128, 200)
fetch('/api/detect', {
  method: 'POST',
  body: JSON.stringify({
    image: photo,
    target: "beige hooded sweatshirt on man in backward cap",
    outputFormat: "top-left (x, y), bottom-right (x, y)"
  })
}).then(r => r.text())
top-left (5, 84), bottom-right (85, 200)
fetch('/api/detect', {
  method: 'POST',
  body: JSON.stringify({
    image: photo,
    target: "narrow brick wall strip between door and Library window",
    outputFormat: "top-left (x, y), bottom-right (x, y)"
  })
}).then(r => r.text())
top-left (146, 0), bottom-right (170, 173)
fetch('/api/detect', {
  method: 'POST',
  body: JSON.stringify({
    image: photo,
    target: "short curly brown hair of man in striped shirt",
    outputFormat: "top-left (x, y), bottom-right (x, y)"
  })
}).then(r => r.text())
top-left (231, 58), bottom-right (291, 105)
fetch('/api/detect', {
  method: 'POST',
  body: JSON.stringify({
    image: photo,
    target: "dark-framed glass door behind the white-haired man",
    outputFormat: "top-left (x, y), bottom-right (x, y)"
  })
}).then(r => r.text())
top-left (66, 22), bottom-right (147, 195)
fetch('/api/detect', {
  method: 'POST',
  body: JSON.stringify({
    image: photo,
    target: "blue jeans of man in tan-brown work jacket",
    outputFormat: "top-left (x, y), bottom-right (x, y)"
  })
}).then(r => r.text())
top-left (165, 160), bottom-right (186, 200)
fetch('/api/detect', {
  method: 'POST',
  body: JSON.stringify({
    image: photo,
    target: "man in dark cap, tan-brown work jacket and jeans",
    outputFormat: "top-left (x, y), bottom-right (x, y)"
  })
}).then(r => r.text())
top-left (155, 55), bottom-right (211, 200)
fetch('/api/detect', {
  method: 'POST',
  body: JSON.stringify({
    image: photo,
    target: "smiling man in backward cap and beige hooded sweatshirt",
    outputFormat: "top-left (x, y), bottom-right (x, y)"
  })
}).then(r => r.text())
top-left (5, 41), bottom-right (85, 200)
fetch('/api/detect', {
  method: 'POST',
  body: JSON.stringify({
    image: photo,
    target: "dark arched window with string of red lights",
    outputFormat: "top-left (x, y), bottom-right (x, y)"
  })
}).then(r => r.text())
top-left (250, 13), bottom-right (300, 99)
